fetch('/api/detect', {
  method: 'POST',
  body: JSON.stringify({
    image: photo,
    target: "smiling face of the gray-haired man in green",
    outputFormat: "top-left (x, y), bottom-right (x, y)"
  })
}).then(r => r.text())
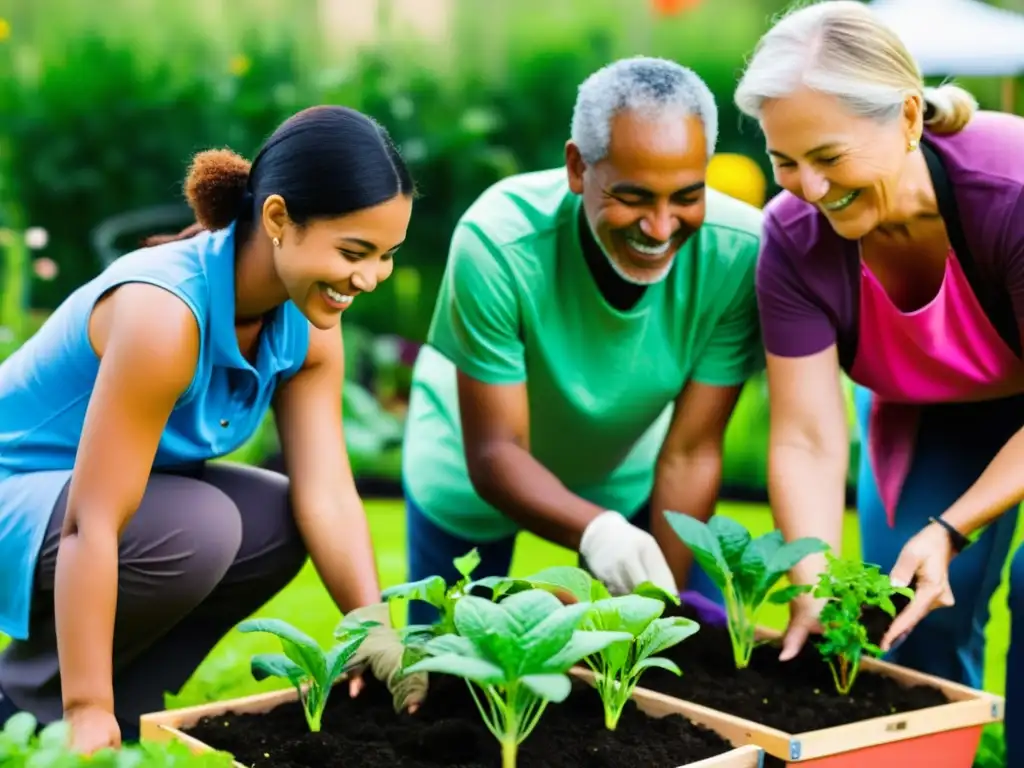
top-left (565, 112), bottom-right (709, 285)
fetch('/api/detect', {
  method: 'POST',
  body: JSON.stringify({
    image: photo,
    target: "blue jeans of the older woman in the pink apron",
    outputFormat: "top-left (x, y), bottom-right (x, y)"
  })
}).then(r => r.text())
top-left (854, 387), bottom-right (1024, 765)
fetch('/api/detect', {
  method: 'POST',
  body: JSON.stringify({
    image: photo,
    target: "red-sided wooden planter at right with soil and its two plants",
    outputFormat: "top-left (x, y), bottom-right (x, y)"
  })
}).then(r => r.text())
top-left (642, 512), bottom-right (1002, 768)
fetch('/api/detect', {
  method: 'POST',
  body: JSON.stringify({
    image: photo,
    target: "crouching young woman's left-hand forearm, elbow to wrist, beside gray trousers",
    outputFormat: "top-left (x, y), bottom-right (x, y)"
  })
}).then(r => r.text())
top-left (53, 526), bottom-right (118, 713)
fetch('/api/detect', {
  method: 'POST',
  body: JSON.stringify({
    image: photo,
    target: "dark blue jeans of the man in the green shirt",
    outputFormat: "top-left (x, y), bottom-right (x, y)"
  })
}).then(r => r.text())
top-left (406, 493), bottom-right (724, 624)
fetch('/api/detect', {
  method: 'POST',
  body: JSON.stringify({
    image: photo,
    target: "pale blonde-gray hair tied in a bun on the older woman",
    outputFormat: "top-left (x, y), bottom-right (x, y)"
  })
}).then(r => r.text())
top-left (734, 0), bottom-right (978, 133)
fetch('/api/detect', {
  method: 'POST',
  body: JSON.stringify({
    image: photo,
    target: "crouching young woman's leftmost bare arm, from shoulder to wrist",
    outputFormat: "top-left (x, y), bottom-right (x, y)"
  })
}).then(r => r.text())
top-left (54, 284), bottom-right (199, 712)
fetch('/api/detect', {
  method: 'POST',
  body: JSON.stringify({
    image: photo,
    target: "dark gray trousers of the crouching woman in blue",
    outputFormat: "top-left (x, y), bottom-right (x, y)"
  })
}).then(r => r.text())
top-left (0, 463), bottom-right (306, 738)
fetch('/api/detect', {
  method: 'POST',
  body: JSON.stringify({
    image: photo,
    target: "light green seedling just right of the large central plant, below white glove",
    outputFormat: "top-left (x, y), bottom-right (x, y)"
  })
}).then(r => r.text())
top-left (581, 595), bottom-right (700, 730)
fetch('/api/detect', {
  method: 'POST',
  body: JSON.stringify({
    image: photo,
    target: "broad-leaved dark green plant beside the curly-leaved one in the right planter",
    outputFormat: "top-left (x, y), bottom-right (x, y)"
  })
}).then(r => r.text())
top-left (665, 511), bottom-right (828, 670)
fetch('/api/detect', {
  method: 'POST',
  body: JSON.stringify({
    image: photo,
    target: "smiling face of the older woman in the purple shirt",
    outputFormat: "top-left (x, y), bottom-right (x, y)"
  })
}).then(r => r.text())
top-left (761, 88), bottom-right (921, 240)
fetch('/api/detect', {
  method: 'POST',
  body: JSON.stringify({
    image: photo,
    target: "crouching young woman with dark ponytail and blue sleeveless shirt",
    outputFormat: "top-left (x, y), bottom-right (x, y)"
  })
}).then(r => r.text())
top-left (0, 106), bottom-right (414, 752)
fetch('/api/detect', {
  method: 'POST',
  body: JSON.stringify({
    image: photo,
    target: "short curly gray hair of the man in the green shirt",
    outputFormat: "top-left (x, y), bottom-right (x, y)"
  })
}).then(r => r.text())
top-left (571, 56), bottom-right (718, 165)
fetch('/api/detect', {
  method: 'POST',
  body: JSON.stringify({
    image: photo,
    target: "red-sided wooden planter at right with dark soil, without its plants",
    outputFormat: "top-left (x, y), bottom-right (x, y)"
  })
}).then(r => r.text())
top-left (637, 608), bottom-right (1004, 768)
